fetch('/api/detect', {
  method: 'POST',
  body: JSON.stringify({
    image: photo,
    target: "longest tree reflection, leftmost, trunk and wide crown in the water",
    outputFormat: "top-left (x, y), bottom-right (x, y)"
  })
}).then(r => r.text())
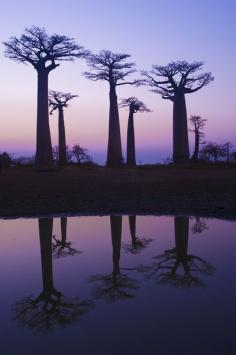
top-left (14, 218), bottom-right (92, 332)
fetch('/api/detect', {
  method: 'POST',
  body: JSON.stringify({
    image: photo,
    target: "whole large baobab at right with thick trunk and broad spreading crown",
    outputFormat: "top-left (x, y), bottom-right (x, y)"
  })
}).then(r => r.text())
top-left (143, 61), bottom-right (214, 163)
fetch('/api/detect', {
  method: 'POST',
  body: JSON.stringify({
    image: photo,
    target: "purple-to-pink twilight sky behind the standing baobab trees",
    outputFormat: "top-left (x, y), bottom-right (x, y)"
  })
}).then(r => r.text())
top-left (0, 0), bottom-right (236, 163)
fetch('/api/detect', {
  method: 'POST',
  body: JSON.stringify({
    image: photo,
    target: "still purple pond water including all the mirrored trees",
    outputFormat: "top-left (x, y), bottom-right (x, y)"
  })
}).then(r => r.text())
top-left (0, 216), bottom-right (236, 355)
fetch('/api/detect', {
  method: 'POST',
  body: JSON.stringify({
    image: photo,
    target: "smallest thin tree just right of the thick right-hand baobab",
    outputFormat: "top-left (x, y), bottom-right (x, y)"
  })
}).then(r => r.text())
top-left (189, 116), bottom-right (207, 162)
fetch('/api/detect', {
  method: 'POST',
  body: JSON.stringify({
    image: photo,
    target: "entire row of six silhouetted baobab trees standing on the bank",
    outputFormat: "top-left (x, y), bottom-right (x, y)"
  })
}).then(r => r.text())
top-left (4, 26), bottom-right (232, 168)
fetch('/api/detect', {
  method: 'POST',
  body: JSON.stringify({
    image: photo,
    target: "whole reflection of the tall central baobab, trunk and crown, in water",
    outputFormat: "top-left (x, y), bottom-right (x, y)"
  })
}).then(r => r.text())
top-left (90, 216), bottom-right (137, 301)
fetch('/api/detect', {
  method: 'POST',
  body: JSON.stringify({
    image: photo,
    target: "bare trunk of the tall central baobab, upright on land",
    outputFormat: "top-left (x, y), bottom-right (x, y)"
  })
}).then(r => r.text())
top-left (106, 84), bottom-right (122, 167)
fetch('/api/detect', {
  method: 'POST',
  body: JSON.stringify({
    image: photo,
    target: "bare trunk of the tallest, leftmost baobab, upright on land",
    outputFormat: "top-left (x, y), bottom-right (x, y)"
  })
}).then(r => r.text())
top-left (36, 70), bottom-right (53, 168)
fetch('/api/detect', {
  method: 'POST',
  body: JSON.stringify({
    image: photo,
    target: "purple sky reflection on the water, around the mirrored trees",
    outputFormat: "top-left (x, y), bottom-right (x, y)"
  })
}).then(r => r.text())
top-left (0, 216), bottom-right (236, 355)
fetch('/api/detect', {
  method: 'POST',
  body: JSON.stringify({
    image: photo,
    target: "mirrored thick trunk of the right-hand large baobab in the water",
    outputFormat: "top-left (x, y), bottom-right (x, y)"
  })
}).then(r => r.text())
top-left (175, 217), bottom-right (189, 266)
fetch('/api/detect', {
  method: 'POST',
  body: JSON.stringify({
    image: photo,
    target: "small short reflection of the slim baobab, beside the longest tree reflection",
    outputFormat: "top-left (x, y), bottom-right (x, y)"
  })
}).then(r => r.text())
top-left (52, 217), bottom-right (82, 258)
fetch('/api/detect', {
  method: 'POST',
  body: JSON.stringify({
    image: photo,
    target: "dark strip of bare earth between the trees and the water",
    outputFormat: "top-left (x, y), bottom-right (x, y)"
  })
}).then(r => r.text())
top-left (0, 166), bottom-right (236, 219)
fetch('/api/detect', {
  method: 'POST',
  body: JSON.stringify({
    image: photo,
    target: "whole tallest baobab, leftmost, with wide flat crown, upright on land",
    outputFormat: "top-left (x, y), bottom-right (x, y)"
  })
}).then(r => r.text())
top-left (4, 26), bottom-right (87, 167)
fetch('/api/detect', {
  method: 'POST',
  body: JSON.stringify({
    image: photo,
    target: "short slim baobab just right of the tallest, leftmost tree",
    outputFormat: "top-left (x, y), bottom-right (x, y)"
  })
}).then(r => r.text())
top-left (49, 90), bottom-right (78, 165)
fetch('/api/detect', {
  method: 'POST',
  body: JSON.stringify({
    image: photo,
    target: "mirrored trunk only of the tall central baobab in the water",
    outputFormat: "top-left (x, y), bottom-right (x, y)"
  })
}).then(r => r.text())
top-left (110, 216), bottom-right (122, 277)
